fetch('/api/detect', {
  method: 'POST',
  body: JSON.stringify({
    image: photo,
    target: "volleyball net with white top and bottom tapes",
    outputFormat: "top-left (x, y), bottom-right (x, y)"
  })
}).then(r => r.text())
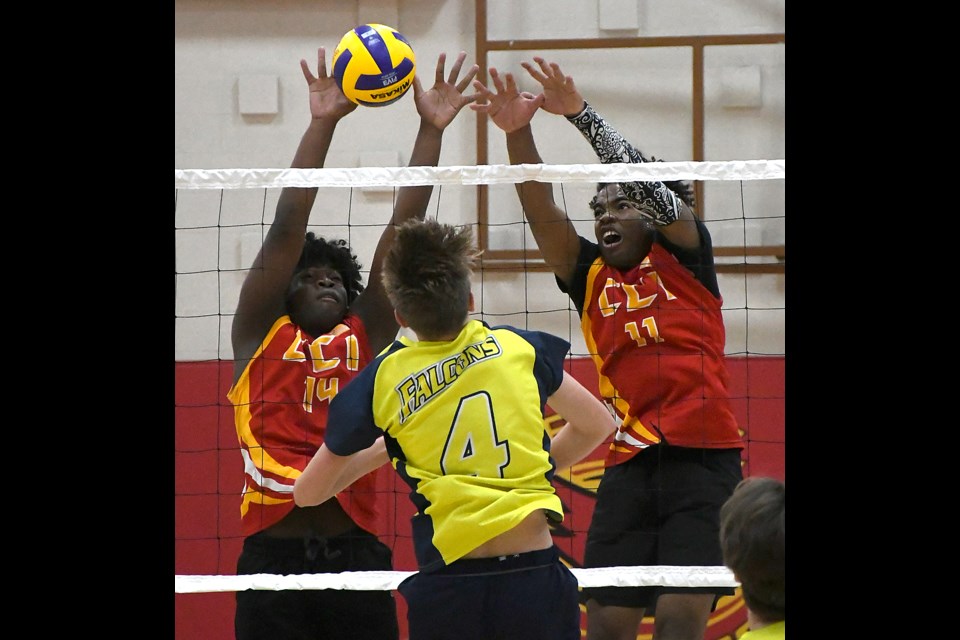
top-left (175, 160), bottom-right (785, 593)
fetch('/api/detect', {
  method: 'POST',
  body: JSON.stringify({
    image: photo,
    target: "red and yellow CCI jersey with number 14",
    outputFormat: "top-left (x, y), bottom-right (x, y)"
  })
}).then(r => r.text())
top-left (227, 314), bottom-right (378, 536)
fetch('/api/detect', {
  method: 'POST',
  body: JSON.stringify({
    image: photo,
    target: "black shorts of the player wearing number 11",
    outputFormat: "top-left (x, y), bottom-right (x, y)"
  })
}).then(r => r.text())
top-left (581, 445), bottom-right (743, 608)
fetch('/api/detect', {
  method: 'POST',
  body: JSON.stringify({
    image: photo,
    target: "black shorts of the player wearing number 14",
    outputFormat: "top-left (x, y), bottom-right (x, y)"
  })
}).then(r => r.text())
top-left (234, 528), bottom-right (400, 640)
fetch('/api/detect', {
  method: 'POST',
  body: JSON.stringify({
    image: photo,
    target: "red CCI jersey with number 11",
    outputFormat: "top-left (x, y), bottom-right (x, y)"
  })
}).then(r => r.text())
top-left (561, 239), bottom-right (743, 466)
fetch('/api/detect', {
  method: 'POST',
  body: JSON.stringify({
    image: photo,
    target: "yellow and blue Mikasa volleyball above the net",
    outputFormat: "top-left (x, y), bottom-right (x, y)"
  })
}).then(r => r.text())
top-left (331, 23), bottom-right (417, 107)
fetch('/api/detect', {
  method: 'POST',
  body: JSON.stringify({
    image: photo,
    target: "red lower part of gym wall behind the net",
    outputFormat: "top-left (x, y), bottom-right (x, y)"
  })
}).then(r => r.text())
top-left (174, 356), bottom-right (785, 640)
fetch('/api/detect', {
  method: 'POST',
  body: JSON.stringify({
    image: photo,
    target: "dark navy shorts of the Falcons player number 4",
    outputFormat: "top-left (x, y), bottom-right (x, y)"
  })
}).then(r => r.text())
top-left (398, 547), bottom-right (580, 640)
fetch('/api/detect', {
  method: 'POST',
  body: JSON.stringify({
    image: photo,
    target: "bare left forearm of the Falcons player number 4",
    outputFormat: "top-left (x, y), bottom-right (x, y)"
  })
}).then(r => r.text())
top-left (293, 437), bottom-right (390, 507)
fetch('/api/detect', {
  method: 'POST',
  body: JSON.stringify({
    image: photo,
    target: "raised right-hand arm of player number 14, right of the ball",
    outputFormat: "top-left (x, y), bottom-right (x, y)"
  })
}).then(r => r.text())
top-left (352, 51), bottom-right (479, 353)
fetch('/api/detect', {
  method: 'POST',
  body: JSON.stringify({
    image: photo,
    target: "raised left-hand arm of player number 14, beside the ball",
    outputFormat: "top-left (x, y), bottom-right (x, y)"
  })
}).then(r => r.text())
top-left (231, 47), bottom-right (357, 381)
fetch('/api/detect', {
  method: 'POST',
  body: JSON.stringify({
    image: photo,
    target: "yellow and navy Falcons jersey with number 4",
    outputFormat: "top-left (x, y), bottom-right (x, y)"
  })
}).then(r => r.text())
top-left (325, 320), bottom-right (570, 572)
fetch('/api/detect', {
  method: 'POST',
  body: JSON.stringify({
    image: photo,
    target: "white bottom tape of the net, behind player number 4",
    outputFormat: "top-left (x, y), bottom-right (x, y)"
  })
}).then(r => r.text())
top-left (176, 566), bottom-right (740, 593)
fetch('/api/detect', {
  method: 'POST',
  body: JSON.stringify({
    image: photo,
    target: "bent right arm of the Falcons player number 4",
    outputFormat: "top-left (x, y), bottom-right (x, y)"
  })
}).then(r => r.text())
top-left (547, 371), bottom-right (617, 469)
